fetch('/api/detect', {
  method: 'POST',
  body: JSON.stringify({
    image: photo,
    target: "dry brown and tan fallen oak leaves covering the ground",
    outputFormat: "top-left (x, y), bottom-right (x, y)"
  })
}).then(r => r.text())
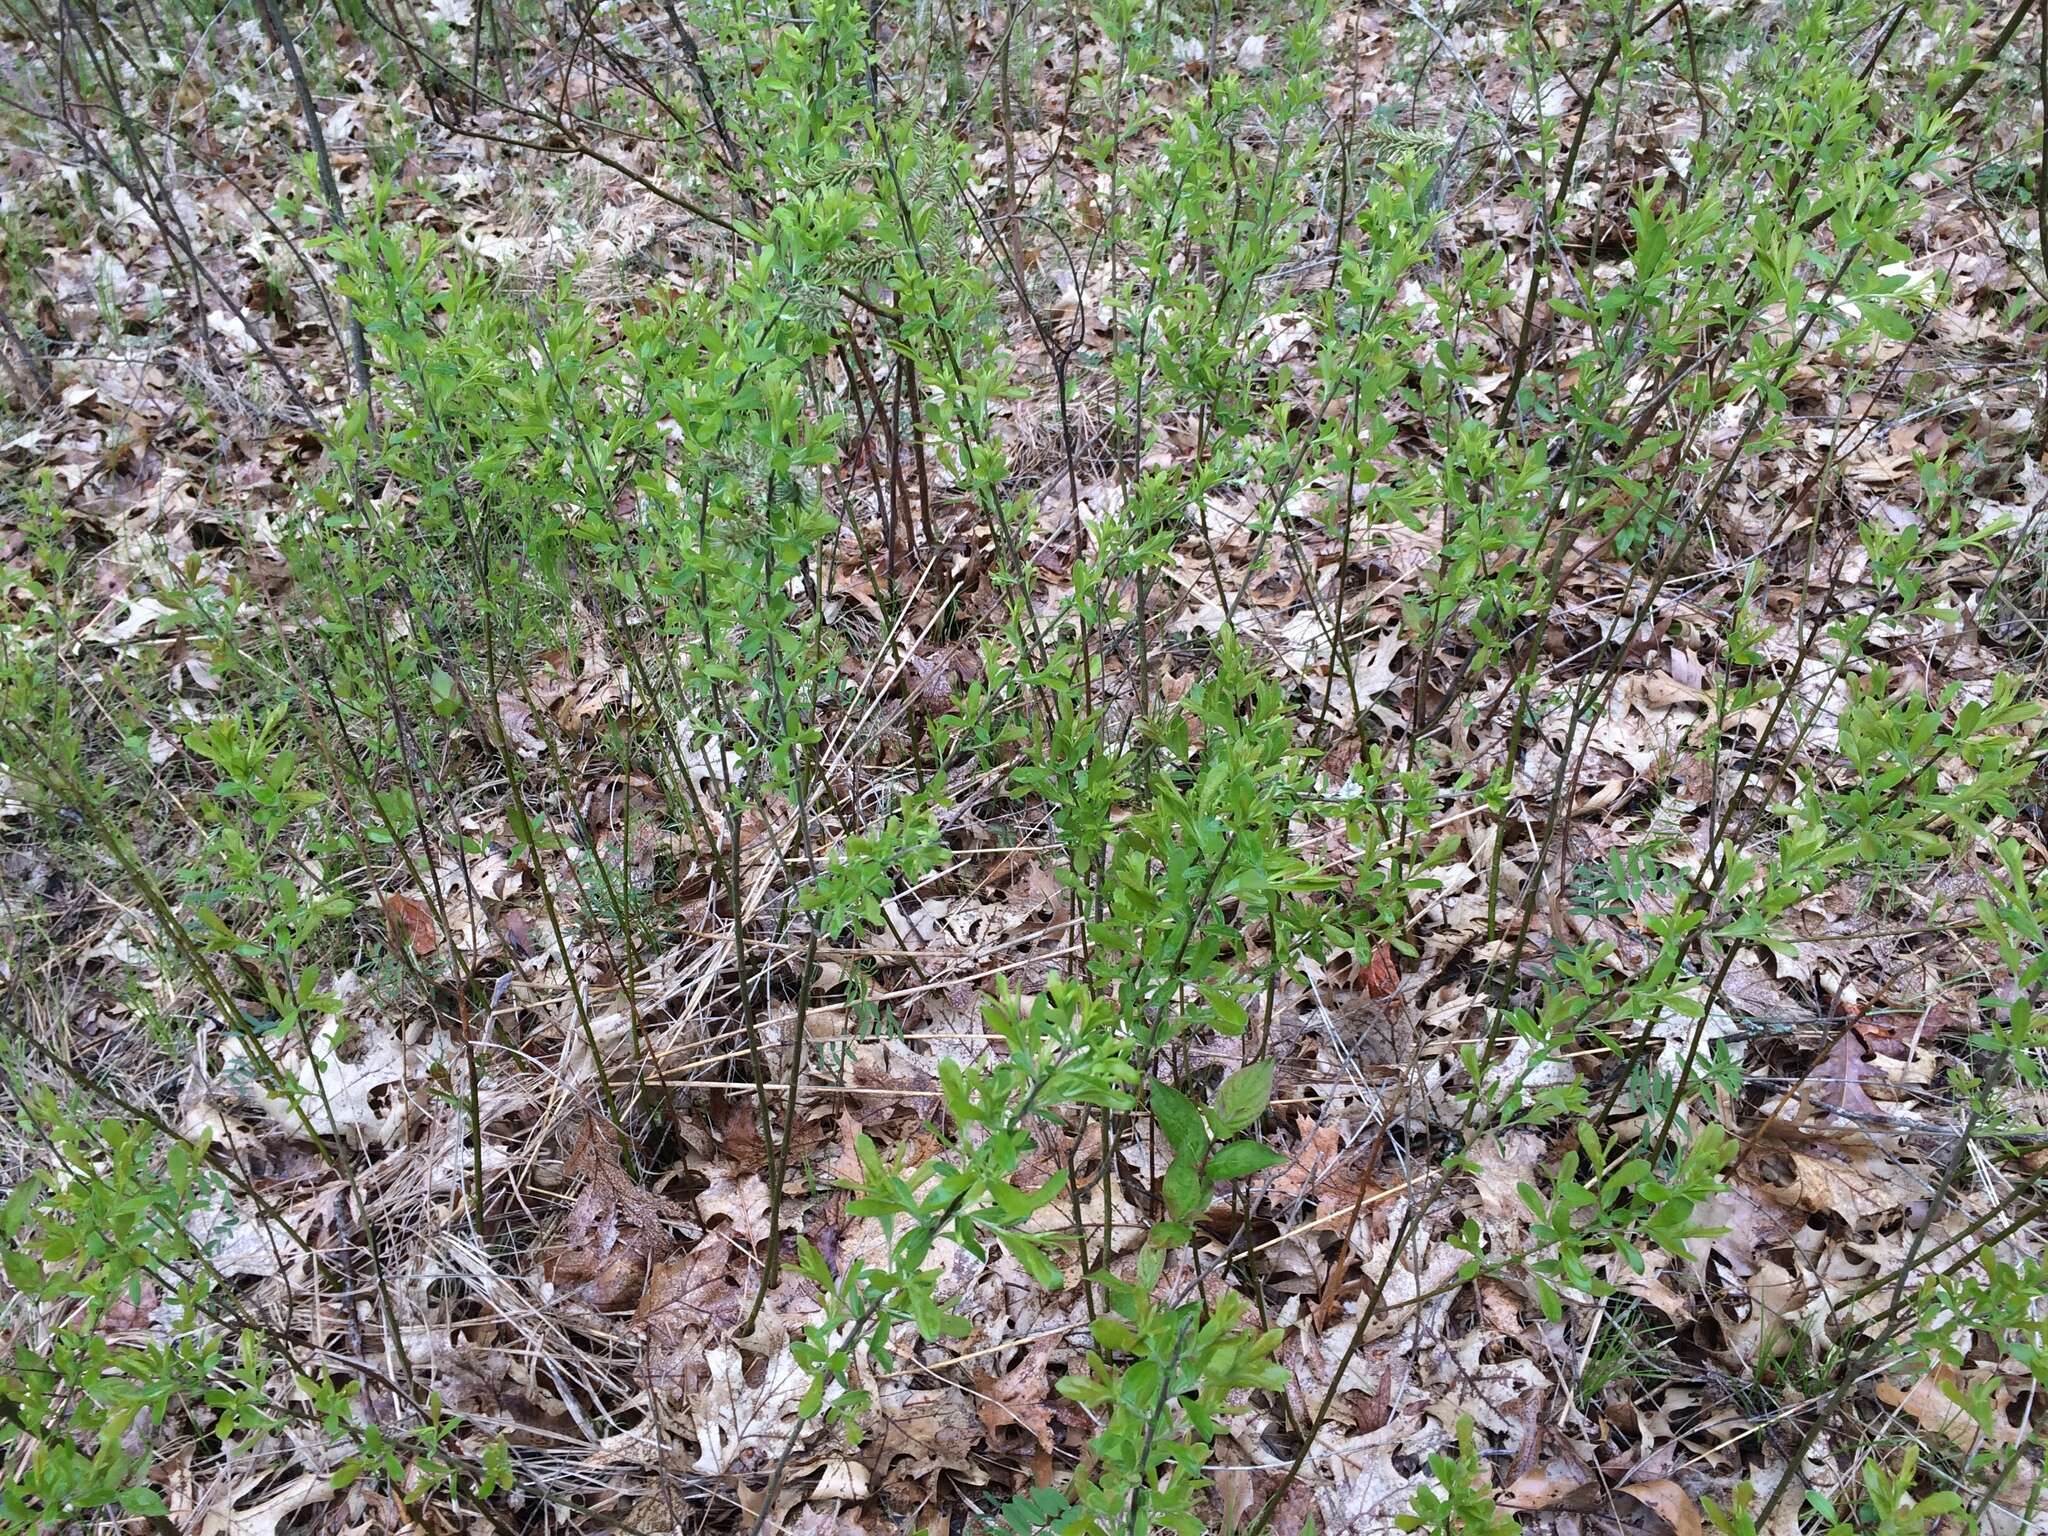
top-left (0, 6), bottom-right (2044, 1536)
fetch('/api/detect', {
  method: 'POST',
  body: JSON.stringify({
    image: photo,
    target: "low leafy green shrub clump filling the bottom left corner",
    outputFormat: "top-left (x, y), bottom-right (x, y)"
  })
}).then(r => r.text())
top-left (0, 1087), bottom-right (512, 1536)
